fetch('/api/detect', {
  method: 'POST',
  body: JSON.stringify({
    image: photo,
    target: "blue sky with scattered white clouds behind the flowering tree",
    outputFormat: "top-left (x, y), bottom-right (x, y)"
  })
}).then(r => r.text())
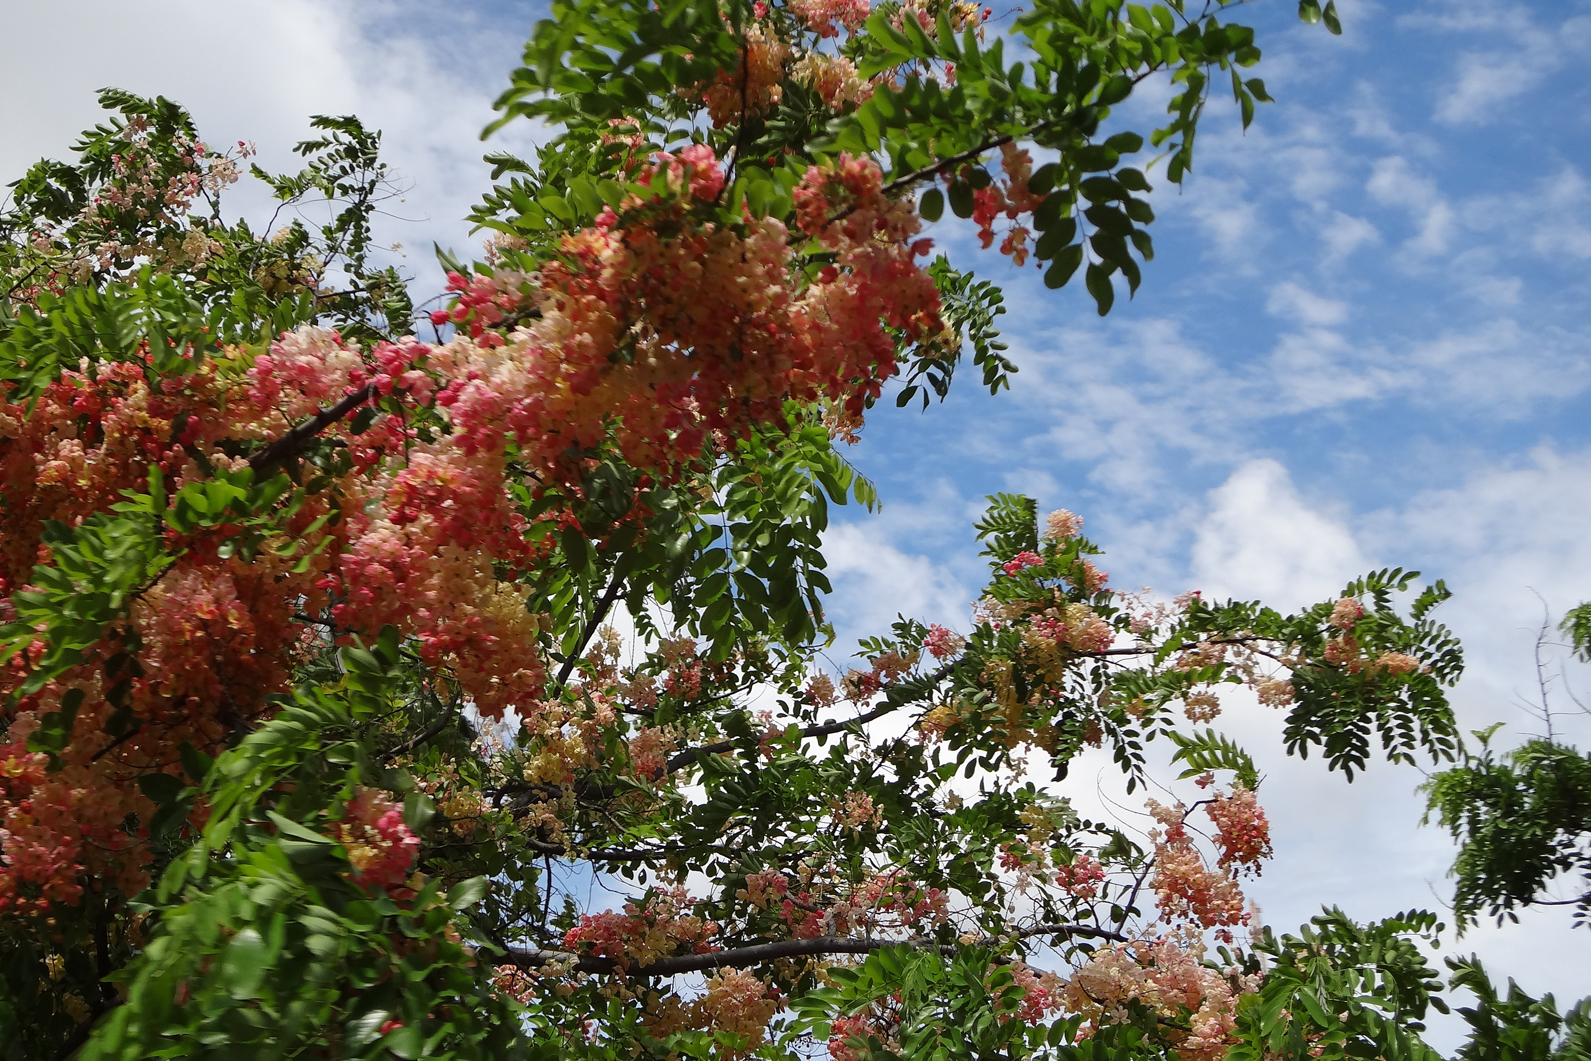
top-left (0, 0), bottom-right (1591, 1036)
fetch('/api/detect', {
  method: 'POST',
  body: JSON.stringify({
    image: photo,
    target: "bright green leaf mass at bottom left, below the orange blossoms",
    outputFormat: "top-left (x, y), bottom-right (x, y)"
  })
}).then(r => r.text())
top-left (80, 628), bottom-right (523, 1061)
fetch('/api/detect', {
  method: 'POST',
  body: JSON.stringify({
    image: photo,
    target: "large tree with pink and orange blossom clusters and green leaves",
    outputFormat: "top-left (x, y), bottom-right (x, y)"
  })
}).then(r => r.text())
top-left (0, 0), bottom-right (1581, 1061)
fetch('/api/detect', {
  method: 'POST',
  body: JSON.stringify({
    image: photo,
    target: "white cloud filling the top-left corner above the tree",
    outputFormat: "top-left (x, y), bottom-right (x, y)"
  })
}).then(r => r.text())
top-left (0, 0), bottom-right (530, 297)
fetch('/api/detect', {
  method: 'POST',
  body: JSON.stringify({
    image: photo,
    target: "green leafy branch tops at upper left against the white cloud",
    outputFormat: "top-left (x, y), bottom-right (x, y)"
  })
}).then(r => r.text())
top-left (0, 89), bottom-right (414, 345)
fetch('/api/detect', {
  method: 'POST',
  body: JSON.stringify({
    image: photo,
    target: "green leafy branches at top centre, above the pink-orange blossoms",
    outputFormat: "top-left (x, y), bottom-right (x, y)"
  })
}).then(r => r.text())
top-left (473, 0), bottom-right (1336, 314)
